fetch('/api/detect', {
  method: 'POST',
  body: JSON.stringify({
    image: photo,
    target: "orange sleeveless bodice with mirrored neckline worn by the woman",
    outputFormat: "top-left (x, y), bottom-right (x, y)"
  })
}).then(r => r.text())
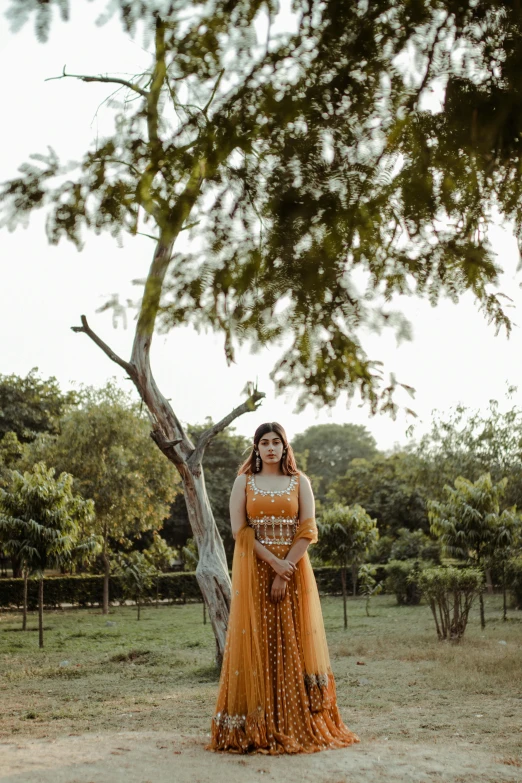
top-left (246, 473), bottom-right (299, 544)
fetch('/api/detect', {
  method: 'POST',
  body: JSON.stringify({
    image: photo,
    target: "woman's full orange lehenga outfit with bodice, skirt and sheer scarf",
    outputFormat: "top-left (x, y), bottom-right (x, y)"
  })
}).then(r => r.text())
top-left (208, 475), bottom-right (359, 755)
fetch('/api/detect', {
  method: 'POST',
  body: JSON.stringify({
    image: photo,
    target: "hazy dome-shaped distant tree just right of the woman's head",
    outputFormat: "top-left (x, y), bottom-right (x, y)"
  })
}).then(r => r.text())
top-left (292, 424), bottom-right (377, 501)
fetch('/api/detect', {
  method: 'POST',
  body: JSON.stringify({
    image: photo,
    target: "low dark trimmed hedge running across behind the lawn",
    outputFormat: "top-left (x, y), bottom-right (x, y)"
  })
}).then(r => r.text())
top-left (0, 566), bottom-right (370, 609)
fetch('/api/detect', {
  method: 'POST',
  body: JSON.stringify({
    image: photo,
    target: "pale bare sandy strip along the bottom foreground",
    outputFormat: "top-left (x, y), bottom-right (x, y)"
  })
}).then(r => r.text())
top-left (0, 731), bottom-right (522, 783)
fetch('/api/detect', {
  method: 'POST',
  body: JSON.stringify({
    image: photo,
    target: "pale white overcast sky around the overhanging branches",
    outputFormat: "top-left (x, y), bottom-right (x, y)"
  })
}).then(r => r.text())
top-left (0, 0), bottom-right (522, 449)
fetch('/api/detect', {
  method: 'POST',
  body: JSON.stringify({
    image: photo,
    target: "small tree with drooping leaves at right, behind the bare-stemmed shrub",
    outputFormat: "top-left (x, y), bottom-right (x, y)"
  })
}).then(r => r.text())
top-left (428, 473), bottom-right (515, 628)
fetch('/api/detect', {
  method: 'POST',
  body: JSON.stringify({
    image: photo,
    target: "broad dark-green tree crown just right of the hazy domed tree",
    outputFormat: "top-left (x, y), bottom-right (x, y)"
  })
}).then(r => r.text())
top-left (328, 453), bottom-right (429, 537)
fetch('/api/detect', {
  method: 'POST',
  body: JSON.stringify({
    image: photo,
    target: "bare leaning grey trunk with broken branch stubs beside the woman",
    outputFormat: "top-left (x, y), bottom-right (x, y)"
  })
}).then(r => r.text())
top-left (72, 228), bottom-right (265, 667)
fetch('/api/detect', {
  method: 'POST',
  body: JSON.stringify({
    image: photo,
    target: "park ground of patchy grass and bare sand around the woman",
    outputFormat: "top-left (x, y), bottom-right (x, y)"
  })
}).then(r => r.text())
top-left (0, 595), bottom-right (522, 783)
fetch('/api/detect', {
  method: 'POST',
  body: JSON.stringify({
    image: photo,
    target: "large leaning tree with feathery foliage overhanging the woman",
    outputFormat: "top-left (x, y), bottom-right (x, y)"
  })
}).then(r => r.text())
top-left (0, 0), bottom-right (522, 658)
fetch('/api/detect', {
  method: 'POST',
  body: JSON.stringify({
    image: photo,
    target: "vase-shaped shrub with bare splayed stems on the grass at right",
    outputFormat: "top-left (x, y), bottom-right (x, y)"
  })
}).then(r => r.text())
top-left (412, 566), bottom-right (483, 642)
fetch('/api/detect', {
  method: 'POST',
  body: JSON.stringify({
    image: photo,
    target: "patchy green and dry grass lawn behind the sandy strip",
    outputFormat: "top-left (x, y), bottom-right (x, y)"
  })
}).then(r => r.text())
top-left (0, 595), bottom-right (522, 774)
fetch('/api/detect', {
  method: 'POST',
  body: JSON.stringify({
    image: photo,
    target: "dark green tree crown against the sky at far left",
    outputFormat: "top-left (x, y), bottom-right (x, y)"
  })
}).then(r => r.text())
top-left (0, 367), bottom-right (77, 443)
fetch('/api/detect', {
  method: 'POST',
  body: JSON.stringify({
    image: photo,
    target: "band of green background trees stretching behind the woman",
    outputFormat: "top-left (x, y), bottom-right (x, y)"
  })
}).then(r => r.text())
top-left (0, 370), bottom-right (522, 640)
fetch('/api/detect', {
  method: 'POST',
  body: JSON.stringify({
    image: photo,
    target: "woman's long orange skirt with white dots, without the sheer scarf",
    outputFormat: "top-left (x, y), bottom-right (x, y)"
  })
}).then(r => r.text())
top-left (208, 543), bottom-right (360, 755)
